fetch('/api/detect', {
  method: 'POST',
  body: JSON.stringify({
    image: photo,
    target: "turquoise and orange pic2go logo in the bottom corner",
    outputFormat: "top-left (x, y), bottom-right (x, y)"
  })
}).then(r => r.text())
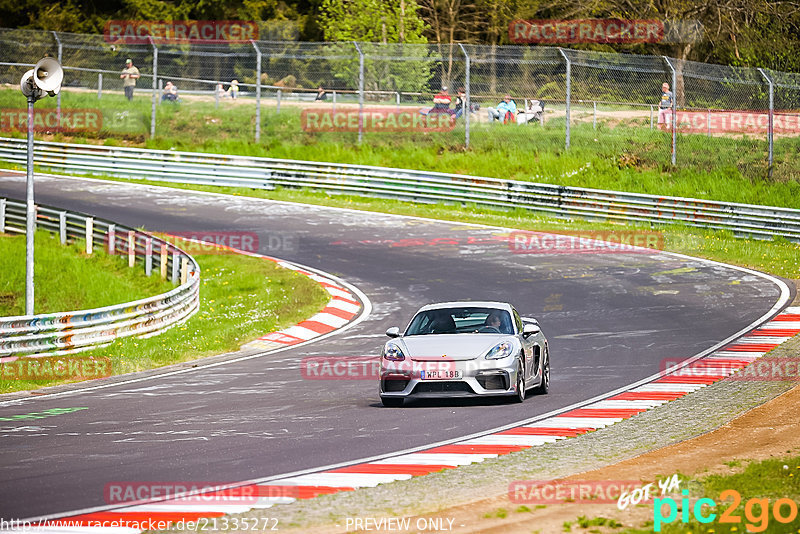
top-left (653, 489), bottom-right (797, 532)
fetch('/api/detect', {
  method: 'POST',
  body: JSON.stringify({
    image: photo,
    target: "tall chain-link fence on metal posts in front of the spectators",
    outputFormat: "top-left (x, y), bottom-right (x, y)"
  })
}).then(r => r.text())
top-left (0, 29), bottom-right (800, 180)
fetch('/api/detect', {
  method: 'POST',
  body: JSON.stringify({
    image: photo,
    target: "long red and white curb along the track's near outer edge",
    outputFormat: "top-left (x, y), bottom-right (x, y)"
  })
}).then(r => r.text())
top-left (17, 308), bottom-right (800, 534)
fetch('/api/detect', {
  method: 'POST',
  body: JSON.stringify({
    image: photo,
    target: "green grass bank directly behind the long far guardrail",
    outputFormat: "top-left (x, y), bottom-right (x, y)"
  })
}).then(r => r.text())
top-left (0, 89), bottom-right (800, 208)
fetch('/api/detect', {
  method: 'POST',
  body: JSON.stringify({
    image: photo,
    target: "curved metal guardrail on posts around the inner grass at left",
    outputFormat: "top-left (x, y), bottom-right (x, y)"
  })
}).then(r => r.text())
top-left (0, 198), bottom-right (200, 361)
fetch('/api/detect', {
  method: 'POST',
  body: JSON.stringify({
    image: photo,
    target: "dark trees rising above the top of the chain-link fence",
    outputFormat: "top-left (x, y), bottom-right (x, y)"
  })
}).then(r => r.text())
top-left (0, 0), bottom-right (800, 72)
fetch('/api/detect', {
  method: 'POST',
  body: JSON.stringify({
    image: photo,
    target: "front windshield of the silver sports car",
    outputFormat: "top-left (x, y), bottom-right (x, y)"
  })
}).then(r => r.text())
top-left (405, 308), bottom-right (514, 336)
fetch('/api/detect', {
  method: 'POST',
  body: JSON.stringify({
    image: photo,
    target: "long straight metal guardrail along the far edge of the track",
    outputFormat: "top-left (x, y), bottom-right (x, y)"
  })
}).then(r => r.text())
top-left (0, 138), bottom-right (800, 241)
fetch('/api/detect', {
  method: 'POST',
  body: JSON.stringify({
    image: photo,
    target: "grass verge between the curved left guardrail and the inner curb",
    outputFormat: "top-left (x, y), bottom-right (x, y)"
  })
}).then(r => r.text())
top-left (0, 237), bottom-right (328, 393)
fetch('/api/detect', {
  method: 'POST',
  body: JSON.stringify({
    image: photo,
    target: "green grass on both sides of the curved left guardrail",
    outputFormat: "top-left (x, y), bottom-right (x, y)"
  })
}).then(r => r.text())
top-left (0, 232), bottom-right (328, 393)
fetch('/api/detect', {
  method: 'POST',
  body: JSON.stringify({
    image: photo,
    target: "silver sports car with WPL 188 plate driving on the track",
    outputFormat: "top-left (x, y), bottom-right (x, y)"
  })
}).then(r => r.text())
top-left (380, 302), bottom-right (550, 407)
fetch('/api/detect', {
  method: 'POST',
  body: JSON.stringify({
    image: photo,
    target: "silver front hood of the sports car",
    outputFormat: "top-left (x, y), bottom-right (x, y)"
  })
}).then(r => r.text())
top-left (401, 334), bottom-right (514, 361)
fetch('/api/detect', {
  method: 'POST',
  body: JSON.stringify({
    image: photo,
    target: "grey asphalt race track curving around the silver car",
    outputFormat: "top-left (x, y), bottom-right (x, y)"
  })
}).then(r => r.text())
top-left (0, 173), bottom-right (793, 518)
